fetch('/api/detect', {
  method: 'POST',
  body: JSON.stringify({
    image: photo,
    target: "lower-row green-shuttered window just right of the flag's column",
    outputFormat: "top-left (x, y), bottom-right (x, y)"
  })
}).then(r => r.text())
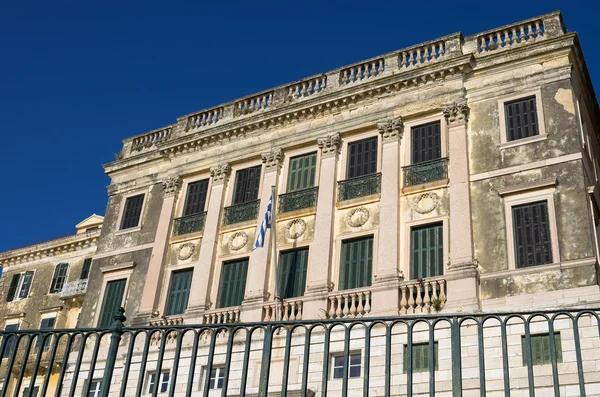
top-left (279, 248), bottom-right (308, 299)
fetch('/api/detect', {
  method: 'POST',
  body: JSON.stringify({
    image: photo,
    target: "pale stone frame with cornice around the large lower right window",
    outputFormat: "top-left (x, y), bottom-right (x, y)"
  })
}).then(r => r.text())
top-left (504, 186), bottom-right (561, 271)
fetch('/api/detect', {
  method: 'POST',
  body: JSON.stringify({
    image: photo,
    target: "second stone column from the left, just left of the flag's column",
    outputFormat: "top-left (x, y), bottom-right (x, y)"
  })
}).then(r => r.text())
top-left (186, 163), bottom-right (231, 323)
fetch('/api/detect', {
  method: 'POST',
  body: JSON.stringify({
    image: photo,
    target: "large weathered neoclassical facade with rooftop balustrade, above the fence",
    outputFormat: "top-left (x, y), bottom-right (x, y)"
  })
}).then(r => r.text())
top-left (72, 13), bottom-right (600, 327)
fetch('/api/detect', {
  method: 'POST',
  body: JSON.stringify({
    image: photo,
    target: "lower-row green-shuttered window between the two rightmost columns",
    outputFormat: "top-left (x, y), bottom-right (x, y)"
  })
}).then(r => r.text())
top-left (410, 223), bottom-right (444, 280)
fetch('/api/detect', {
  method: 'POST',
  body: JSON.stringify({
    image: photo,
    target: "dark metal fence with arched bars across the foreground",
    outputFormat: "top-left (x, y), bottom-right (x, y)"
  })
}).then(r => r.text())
top-left (0, 309), bottom-right (600, 397)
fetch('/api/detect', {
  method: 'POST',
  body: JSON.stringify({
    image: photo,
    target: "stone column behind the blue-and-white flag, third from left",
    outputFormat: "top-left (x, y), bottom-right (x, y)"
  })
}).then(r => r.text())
top-left (241, 149), bottom-right (283, 321)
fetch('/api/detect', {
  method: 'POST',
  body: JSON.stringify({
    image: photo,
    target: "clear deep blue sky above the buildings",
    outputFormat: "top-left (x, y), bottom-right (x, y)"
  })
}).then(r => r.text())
top-left (0, 0), bottom-right (600, 252)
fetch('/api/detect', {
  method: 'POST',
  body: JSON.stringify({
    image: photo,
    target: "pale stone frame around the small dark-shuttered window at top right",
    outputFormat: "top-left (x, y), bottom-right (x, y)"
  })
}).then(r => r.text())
top-left (498, 87), bottom-right (548, 149)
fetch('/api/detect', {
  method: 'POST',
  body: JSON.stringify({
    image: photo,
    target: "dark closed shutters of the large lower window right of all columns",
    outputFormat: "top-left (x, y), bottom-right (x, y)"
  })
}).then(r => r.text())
top-left (512, 200), bottom-right (552, 268)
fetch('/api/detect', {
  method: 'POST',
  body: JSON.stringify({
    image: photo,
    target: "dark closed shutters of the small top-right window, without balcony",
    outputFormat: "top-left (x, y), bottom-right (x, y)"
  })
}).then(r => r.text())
top-left (504, 95), bottom-right (540, 141)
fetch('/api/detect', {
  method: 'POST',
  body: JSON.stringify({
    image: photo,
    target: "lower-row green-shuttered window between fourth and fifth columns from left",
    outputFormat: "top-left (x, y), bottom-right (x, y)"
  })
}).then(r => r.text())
top-left (340, 236), bottom-right (373, 290)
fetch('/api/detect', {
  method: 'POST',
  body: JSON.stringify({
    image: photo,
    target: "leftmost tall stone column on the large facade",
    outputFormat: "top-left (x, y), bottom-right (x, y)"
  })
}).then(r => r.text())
top-left (134, 176), bottom-right (181, 324)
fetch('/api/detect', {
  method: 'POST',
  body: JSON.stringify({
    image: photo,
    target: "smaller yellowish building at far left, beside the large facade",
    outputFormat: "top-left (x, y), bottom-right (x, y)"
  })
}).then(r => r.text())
top-left (0, 214), bottom-right (104, 397)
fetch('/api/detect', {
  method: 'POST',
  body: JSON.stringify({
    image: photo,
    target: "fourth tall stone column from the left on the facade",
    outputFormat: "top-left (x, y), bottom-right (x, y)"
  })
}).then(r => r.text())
top-left (302, 134), bottom-right (342, 319)
